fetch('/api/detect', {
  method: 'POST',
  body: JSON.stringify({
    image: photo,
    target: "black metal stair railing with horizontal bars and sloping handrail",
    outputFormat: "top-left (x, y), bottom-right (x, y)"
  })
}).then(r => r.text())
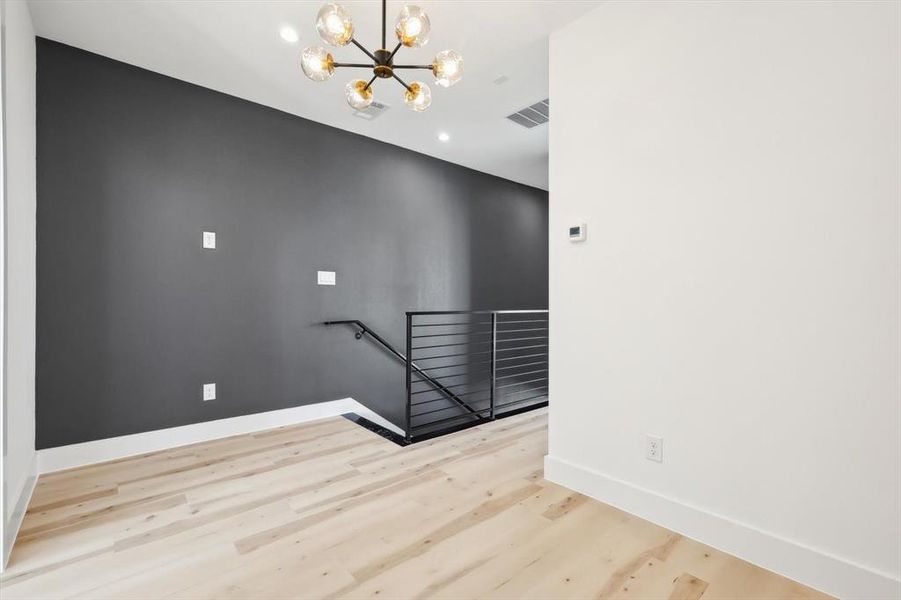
top-left (325, 310), bottom-right (548, 442)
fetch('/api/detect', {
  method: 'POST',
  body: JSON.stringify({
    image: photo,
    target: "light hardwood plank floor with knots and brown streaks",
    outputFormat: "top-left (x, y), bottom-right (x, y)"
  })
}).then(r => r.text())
top-left (0, 410), bottom-right (826, 600)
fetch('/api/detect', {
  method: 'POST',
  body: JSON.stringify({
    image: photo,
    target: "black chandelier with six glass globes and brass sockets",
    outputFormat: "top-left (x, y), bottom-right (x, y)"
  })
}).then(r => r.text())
top-left (301, 0), bottom-right (463, 112)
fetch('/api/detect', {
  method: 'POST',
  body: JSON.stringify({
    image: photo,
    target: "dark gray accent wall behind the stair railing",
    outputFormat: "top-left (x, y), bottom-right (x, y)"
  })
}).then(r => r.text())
top-left (37, 39), bottom-right (548, 448)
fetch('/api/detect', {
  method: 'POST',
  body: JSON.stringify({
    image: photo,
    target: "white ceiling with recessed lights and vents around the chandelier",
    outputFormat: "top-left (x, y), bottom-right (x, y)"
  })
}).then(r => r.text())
top-left (30, 0), bottom-right (599, 189)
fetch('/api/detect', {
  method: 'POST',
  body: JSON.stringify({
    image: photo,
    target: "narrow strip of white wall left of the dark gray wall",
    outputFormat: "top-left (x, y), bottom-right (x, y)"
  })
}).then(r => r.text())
top-left (3, 0), bottom-right (36, 563)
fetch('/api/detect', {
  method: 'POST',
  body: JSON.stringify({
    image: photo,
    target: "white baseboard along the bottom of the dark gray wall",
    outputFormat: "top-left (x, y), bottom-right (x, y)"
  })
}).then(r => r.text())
top-left (37, 398), bottom-right (403, 473)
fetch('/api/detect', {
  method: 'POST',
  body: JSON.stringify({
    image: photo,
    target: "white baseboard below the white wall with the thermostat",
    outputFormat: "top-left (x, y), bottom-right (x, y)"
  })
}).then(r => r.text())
top-left (544, 456), bottom-right (901, 600)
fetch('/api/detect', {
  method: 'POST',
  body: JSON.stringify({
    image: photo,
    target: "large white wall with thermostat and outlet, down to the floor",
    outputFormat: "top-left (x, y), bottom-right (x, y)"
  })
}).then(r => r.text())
top-left (547, 1), bottom-right (901, 598)
